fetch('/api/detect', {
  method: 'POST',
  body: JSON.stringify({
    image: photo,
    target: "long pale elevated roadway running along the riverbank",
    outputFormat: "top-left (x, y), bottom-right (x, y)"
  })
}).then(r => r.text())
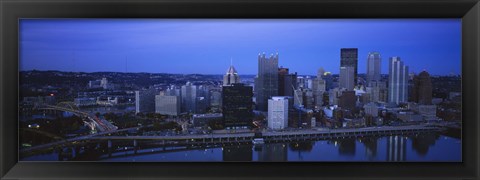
top-left (20, 125), bottom-right (445, 157)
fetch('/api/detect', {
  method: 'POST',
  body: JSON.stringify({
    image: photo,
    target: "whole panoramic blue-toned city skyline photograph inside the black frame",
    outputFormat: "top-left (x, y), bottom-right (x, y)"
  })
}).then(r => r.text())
top-left (18, 18), bottom-right (463, 162)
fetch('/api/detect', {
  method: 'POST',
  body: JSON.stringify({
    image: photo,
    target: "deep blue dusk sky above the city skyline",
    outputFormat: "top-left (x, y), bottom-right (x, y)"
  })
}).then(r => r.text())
top-left (19, 19), bottom-right (461, 75)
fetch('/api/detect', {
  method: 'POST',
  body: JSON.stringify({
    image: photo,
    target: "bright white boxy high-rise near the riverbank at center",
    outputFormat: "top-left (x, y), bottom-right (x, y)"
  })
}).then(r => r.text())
top-left (268, 96), bottom-right (288, 129)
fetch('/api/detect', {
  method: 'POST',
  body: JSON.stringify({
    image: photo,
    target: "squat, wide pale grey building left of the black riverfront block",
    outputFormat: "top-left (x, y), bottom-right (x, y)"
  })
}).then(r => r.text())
top-left (155, 95), bottom-right (181, 116)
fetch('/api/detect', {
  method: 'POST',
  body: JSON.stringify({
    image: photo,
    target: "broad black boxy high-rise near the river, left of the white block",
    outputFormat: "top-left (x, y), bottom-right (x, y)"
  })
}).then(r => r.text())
top-left (222, 83), bottom-right (253, 129)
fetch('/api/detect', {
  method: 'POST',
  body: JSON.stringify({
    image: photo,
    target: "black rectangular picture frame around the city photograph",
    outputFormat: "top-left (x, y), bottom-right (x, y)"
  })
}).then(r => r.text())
top-left (0, 0), bottom-right (480, 179)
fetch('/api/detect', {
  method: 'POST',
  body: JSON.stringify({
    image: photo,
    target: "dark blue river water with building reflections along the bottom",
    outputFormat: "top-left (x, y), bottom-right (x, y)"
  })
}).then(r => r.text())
top-left (22, 133), bottom-right (461, 162)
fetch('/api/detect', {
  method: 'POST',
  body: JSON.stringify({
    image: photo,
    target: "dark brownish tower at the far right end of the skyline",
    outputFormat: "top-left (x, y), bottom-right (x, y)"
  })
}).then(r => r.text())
top-left (412, 71), bottom-right (432, 105)
